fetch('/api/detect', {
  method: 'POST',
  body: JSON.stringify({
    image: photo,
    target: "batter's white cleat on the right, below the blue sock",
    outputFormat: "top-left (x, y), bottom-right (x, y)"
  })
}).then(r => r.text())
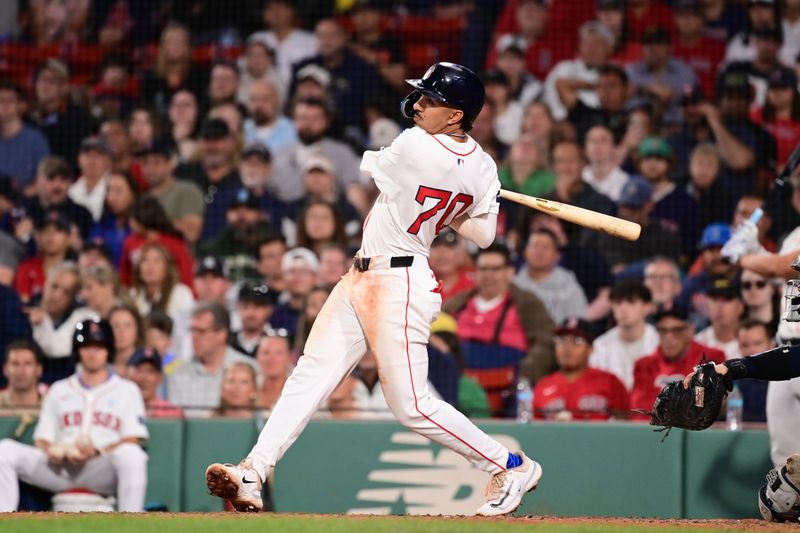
top-left (477, 452), bottom-right (542, 516)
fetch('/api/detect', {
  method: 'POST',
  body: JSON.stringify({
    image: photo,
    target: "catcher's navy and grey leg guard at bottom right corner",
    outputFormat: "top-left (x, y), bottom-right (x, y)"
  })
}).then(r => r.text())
top-left (758, 453), bottom-right (800, 522)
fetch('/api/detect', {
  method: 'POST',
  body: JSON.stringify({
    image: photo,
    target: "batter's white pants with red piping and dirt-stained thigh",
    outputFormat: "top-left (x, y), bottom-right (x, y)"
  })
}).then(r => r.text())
top-left (248, 256), bottom-right (508, 479)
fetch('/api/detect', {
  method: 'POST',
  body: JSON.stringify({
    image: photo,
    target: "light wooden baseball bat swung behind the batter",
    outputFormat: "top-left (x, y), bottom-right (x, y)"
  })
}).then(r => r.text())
top-left (500, 189), bottom-right (642, 241)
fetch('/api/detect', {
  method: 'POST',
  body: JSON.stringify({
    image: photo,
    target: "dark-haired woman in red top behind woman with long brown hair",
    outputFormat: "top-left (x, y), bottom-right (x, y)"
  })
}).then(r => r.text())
top-left (119, 196), bottom-right (194, 287)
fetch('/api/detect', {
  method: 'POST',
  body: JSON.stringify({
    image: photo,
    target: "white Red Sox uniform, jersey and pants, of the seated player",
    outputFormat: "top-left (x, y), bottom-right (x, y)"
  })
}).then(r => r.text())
top-left (0, 374), bottom-right (148, 512)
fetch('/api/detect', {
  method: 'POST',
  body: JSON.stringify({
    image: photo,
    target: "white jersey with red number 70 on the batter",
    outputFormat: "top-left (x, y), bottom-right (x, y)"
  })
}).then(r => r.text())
top-left (359, 127), bottom-right (500, 257)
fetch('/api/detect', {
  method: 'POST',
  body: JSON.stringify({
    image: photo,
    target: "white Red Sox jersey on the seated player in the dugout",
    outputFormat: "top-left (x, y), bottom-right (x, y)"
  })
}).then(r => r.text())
top-left (33, 374), bottom-right (148, 449)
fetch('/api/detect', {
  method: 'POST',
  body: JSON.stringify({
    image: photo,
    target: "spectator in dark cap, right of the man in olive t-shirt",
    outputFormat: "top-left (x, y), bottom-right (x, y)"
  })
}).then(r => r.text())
top-left (175, 118), bottom-right (242, 242)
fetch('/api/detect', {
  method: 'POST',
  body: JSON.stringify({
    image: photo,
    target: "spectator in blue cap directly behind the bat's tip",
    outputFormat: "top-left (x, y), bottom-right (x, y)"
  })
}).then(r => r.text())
top-left (590, 176), bottom-right (681, 274)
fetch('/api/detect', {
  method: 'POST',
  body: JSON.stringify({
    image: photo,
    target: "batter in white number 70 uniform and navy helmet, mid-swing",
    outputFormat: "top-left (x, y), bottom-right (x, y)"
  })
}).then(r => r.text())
top-left (206, 63), bottom-right (542, 515)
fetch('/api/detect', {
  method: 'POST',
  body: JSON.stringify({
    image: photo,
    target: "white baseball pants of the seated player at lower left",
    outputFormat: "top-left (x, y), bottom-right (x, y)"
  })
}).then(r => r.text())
top-left (0, 439), bottom-right (147, 512)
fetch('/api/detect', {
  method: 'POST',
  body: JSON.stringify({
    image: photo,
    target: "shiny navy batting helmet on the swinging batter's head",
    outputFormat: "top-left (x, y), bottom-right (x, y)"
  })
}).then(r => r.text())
top-left (401, 62), bottom-right (486, 131)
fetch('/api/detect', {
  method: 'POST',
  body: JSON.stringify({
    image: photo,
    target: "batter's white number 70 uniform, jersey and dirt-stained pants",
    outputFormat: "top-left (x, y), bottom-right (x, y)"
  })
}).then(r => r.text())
top-left (248, 127), bottom-right (508, 479)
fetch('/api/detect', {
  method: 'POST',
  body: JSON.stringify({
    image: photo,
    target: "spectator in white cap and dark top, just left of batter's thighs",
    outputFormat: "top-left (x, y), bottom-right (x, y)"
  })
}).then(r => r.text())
top-left (270, 248), bottom-right (319, 337)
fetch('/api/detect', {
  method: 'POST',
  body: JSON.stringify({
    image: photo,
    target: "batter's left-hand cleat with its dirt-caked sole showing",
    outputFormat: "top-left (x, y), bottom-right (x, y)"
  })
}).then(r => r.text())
top-left (206, 459), bottom-right (264, 513)
